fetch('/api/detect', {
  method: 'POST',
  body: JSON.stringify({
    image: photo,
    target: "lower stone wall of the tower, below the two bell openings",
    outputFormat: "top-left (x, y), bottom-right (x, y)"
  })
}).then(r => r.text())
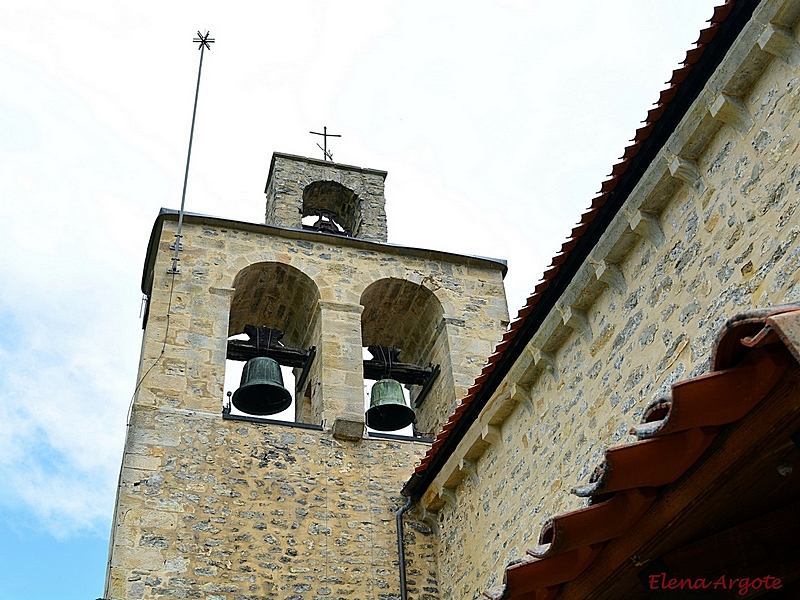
top-left (106, 407), bottom-right (439, 600)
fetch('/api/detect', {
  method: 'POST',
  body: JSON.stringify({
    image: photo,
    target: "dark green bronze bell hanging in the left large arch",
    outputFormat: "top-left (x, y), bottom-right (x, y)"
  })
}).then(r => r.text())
top-left (231, 356), bottom-right (292, 416)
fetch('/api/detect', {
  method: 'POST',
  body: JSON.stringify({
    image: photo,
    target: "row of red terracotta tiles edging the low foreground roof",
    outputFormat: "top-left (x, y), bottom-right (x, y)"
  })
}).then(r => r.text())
top-left (484, 303), bottom-right (800, 600)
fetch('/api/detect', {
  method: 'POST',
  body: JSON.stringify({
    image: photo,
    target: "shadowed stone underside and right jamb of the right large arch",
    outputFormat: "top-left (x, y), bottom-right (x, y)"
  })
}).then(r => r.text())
top-left (360, 277), bottom-right (454, 434)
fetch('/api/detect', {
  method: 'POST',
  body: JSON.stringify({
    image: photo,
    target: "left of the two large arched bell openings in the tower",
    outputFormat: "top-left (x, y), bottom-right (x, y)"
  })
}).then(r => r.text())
top-left (225, 262), bottom-right (319, 423)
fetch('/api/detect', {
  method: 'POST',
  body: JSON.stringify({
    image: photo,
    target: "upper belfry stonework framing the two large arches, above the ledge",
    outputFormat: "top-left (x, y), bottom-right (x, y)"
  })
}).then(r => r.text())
top-left (137, 217), bottom-right (508, 432)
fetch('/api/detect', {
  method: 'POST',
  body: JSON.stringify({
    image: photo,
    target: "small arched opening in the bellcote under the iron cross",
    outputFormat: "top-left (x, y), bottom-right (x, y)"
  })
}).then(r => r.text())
top-left (302, 181), bottom-right (361, 236)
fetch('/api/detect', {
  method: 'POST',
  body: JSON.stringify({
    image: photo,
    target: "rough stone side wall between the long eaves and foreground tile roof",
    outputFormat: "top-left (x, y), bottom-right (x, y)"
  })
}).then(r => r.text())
top-left (429, 7), bottom-right (800, 598)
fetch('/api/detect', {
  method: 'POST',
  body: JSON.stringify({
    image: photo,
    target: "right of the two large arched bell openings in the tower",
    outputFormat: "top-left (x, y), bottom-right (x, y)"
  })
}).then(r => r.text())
top-left (361, 278), bottom-right (452, 436)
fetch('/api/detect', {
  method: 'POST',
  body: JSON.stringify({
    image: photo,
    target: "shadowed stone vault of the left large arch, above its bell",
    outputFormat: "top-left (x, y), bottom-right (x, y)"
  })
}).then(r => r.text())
top-left (228, 262), bottom-right (320, 347)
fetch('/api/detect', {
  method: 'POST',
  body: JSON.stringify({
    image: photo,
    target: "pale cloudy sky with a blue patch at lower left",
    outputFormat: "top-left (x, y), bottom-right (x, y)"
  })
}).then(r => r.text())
top-left (0, 0), bottom-right (721, 600)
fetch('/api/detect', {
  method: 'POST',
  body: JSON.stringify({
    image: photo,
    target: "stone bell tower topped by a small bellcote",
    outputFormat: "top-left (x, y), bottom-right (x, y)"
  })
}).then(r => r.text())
top-left (105, 153), bottom-right (508, 600)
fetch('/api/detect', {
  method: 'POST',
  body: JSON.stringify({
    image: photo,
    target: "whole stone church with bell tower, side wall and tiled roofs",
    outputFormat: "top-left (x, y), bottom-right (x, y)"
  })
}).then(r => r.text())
top-left (105, 0), bottom-right (800, 600)
